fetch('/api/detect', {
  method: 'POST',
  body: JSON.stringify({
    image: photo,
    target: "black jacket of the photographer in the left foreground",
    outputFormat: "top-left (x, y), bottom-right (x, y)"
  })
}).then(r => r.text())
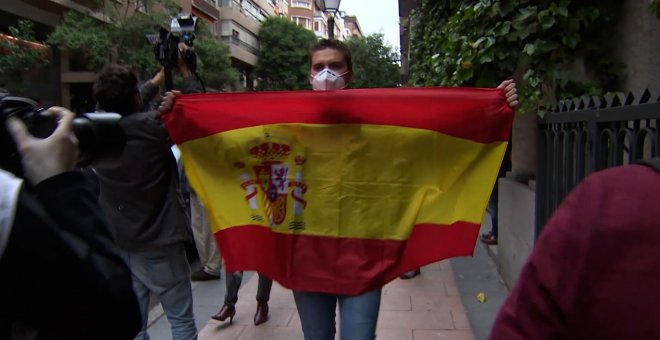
top-left (0, 172), bottom-right (141, 340)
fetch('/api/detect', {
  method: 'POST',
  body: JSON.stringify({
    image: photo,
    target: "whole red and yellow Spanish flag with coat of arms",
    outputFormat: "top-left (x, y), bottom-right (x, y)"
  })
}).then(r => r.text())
top-left (163, 88), bottom-right (513, 295)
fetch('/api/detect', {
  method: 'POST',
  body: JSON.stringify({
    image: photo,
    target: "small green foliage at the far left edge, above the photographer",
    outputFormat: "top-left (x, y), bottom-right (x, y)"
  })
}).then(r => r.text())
top-left (0, 20), bottom-right (48, 93)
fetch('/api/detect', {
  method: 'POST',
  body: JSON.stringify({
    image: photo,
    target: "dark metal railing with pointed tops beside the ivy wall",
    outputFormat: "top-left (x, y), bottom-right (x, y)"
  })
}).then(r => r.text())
top-left (536, 89), bottom-right (660, 236)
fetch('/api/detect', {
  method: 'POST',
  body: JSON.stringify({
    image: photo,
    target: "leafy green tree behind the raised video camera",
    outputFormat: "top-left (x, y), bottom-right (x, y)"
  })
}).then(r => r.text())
top-left (48, 0), bottom-right (238, 89)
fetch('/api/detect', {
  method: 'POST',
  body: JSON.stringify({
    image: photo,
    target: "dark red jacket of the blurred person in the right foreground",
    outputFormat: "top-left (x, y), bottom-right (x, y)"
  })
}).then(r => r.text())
top-left (490, 159), bottom-right (660, 340)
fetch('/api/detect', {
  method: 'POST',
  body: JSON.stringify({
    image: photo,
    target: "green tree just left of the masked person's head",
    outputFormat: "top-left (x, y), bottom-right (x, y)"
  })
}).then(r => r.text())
top-left (255, 17), bottom-right (316, 91)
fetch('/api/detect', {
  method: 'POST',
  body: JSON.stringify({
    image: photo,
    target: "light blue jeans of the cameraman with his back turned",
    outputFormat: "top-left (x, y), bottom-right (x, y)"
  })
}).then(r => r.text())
top-left (122, 243), bottom-right (197, 340)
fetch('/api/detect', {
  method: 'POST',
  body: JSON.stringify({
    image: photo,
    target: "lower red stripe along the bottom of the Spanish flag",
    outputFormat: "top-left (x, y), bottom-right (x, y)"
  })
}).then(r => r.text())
top-left (215, 222), bottom-right (480, 295)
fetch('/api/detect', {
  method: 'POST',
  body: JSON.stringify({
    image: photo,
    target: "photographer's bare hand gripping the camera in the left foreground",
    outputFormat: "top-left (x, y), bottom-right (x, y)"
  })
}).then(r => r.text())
top-left (7, 106), bottom-right (79, 185)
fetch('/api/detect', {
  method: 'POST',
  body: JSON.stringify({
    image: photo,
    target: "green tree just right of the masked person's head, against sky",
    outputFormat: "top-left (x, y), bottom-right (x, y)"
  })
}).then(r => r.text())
top-left (346, 33), bottom-right (401, 88)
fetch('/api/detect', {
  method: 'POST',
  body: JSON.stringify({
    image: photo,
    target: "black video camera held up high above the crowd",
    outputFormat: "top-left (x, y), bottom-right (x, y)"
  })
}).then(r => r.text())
top-left (145, 12), bottom-right (197, 90)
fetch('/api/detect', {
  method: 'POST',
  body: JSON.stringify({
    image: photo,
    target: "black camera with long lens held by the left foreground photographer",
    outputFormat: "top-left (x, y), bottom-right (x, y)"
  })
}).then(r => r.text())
top-left (0, 96), bottom-right (126, 177)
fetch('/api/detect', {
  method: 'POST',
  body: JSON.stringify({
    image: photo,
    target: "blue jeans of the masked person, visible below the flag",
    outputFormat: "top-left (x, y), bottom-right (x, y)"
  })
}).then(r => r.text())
top-left (293, 288), bottom-right (381, 340)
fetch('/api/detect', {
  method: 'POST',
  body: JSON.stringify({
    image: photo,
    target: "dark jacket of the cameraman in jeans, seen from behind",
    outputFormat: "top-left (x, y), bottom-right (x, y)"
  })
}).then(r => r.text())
top-left (96, 78), bottom-right (199, 249)
